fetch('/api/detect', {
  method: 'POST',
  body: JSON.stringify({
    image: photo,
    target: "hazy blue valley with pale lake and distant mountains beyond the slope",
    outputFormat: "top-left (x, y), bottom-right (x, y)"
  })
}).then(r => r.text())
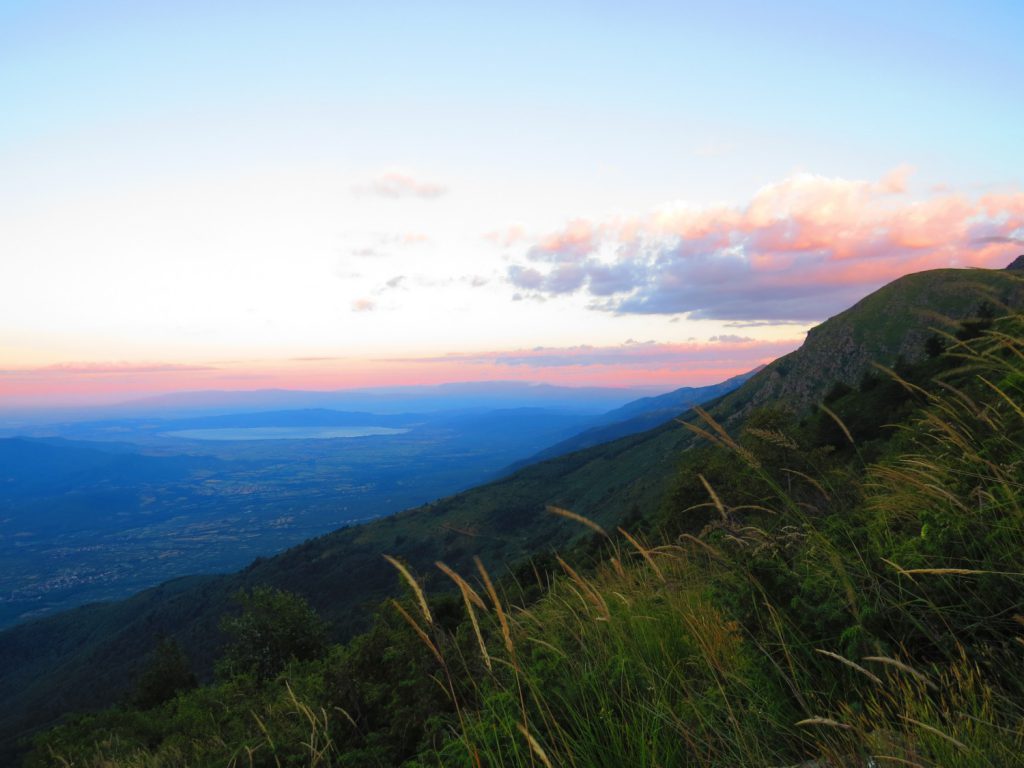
top-left (0, 382), bottom-right (753, 629)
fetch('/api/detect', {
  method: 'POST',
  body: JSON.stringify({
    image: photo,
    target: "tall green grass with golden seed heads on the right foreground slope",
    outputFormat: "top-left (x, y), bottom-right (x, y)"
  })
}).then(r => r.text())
top-left (405, 319), bottom-right (1024, 767)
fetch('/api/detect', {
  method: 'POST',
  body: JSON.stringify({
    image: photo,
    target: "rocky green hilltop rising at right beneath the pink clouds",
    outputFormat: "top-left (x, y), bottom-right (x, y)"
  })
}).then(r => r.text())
top-left (722, 268), bottom-right (1024, 421)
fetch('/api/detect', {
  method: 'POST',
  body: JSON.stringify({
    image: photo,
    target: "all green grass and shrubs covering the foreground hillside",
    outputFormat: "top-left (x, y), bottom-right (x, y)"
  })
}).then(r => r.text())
top-left (27, 299), bottom-right (1024, 768)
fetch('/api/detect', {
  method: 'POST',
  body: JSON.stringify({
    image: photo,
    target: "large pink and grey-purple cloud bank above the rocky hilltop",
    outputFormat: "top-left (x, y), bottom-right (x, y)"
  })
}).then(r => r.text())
top-left (507, 168), bottom-right (1024, 322)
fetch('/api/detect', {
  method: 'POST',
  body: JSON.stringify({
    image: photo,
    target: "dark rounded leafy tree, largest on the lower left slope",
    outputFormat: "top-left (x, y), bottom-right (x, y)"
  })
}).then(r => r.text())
top-left (218, 587), bottom-right (327, 682)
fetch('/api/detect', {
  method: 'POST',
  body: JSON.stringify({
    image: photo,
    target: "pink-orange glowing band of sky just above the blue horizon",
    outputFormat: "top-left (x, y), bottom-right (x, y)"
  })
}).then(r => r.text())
top-left (0, 339), bottom-right (801, 408)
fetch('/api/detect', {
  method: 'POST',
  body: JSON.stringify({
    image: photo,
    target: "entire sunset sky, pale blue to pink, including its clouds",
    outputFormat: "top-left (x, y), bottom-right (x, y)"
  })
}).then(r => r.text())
top-left (0, 0), bottom-right (1024, 408)
